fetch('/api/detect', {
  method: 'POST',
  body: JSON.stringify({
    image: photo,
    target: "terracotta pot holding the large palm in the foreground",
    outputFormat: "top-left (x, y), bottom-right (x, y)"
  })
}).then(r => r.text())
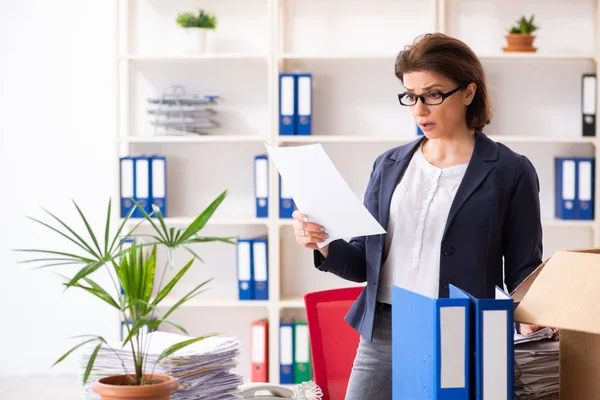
top-left (93, 374), bottom-right (179, 400)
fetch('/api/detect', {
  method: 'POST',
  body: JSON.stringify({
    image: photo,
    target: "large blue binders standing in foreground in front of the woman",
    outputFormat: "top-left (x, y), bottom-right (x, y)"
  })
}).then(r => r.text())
top-left (392, 285), bottom-right (514, 400)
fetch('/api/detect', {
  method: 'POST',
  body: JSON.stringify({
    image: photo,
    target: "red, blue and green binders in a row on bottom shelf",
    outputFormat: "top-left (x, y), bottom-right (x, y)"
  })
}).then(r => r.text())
top-left (250, 320), bottom-right (313, 385)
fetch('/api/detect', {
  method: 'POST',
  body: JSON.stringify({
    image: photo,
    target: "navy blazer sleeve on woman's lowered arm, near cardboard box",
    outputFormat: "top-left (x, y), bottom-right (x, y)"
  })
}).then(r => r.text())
top-left (503, 156), bottom-right (543, 293)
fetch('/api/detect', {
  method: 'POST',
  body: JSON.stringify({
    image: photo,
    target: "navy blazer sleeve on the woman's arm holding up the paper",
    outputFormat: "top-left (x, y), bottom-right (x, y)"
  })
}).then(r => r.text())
top-left (313, 157), bottom-right (381, 283)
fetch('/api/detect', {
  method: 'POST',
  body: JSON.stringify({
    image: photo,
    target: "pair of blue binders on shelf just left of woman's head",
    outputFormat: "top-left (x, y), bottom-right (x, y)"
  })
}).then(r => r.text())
top-left (279, 73), bottom-right (312, 135)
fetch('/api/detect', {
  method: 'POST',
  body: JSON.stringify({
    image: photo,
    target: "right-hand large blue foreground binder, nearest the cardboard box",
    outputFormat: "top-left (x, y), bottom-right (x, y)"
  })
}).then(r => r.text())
top-left (450, 286), bottom-right (515, 400)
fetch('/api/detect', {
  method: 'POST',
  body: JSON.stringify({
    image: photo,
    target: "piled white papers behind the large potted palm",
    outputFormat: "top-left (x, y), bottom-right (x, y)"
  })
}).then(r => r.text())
top-left (80, 331), bottom-right (243, 400)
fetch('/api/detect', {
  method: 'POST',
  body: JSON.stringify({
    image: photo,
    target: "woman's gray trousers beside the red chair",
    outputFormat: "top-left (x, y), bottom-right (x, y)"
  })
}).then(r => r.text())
top-left (344, 307), bottom-right (392, 400)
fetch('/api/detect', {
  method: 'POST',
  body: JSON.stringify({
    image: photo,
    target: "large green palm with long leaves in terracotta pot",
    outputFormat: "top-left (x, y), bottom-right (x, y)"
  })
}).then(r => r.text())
top-left (18, 191), bottom-right (235, 400)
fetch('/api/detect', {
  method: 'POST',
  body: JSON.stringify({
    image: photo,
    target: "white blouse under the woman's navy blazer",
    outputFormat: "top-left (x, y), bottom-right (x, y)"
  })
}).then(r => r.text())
top-left (377, 146), bottom-right (468, 304)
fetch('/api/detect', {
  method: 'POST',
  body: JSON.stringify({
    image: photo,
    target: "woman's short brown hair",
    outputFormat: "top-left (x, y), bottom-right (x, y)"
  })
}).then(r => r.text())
top-left (395, 33), bottom-right (492, 132)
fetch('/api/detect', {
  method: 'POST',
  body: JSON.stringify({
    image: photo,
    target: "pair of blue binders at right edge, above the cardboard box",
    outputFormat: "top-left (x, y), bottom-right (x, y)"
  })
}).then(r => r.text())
top-left (554, 157), bottom-right (595, 220)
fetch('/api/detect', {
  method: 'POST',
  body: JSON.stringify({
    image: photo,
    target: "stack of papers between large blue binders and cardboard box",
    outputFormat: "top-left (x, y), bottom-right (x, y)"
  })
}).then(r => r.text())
top-left (515, 339), bottom-right (559, 400)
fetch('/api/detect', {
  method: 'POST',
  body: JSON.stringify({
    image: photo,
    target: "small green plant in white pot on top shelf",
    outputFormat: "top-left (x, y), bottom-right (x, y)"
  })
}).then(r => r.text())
top-left (177, 10), bottom-right (217, 53)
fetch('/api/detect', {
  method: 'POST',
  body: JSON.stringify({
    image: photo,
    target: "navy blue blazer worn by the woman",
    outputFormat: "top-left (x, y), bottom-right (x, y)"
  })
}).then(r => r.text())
top-left (314, 133), bottom-right (542, 340)
